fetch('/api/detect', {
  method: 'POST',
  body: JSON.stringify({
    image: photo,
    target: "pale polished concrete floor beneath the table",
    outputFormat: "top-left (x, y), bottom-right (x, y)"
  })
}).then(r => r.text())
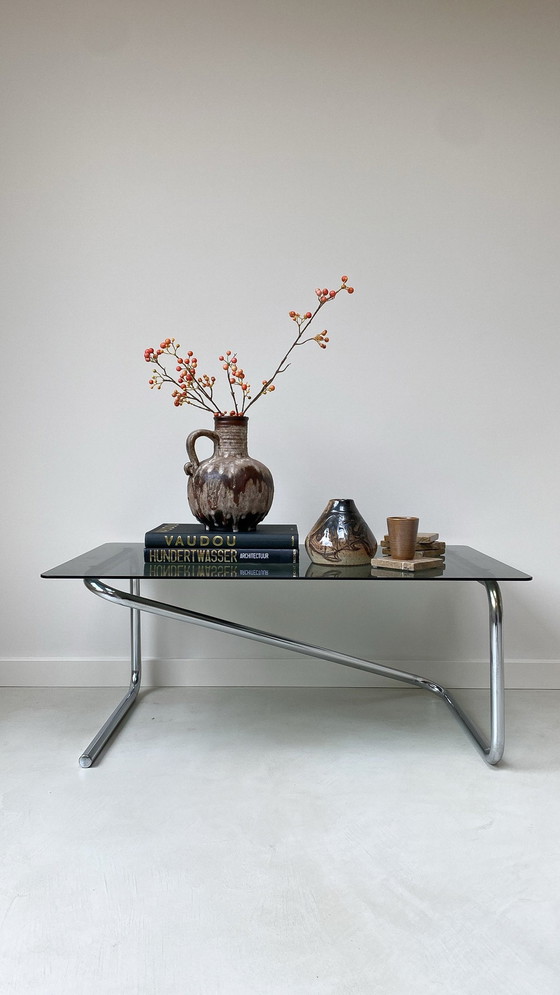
top-left (0, 688), bottom-right (560, 995)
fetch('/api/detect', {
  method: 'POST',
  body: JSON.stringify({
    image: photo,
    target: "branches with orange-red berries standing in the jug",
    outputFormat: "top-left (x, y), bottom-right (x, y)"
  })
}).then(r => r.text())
top-left (144, 276), bottom-right (354, 418)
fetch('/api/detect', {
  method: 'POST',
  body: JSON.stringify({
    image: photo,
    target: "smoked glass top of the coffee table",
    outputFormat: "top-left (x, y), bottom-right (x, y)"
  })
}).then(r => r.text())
top-left (41, 542), bottom-right (531, 582)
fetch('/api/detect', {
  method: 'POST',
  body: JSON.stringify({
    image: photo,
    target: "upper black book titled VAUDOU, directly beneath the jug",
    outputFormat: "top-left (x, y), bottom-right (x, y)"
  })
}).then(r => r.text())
top-left (144, 522), bottom-right (299, 549)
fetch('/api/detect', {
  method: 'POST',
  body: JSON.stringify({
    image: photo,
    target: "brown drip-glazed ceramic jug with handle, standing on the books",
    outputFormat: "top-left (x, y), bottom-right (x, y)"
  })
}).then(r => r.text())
top-left (185, 415), bottom-right (274, 532)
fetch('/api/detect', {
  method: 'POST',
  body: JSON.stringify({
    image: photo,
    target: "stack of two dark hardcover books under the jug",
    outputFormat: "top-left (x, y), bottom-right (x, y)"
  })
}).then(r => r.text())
top-left (144, 522), bottom-right (299, 577)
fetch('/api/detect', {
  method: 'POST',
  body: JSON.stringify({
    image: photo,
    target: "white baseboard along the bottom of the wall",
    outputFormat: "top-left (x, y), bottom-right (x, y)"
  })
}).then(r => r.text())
top-left (0, 657), bottom-right (560, 690)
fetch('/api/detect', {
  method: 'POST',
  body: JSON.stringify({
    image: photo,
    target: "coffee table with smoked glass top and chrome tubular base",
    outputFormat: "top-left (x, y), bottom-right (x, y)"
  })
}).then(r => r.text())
top-left (41, 543), bottom-right (532, 767)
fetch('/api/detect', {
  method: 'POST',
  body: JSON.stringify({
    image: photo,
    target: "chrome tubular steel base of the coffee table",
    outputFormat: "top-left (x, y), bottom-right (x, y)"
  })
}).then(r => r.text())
top-left (80, 577), bottom-right (505, 767)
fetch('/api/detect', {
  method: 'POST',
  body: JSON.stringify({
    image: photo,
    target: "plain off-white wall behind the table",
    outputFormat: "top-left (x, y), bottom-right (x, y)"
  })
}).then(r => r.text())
top-left (0, 0), bottom-right (560, 687)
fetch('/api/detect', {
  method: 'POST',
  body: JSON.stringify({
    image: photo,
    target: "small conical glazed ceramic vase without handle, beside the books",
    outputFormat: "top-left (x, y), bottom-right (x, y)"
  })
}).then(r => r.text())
top-left (305, 498), bottom-right (377, 567)
